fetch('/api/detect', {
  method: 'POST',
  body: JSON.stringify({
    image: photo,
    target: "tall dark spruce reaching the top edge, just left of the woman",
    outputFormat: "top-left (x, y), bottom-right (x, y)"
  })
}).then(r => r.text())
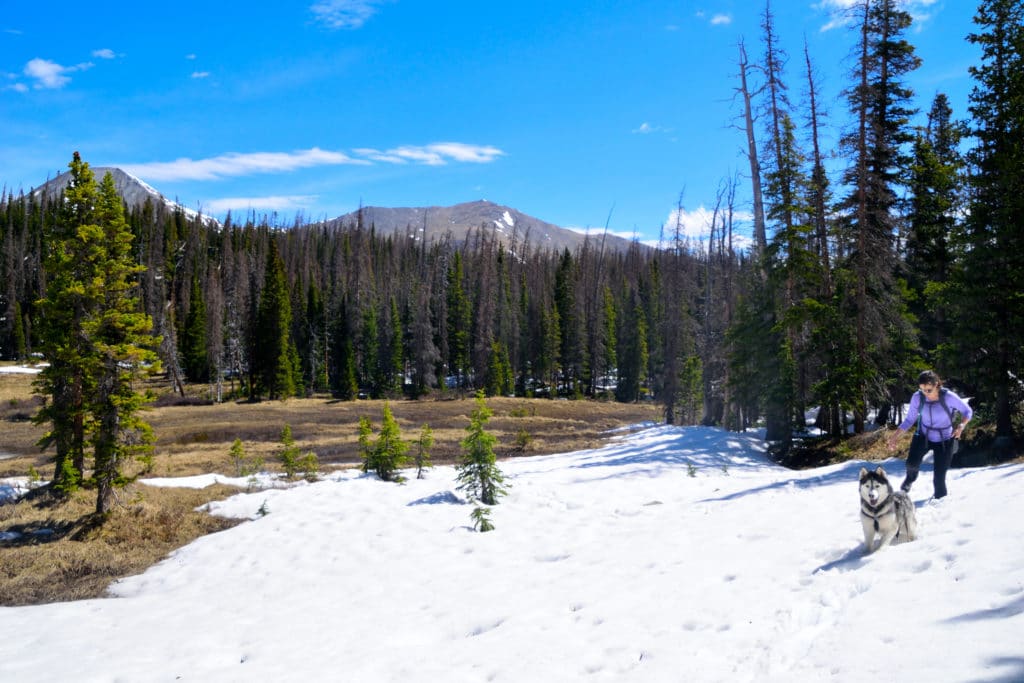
top-left (842, 0), bottom-right (921, 433)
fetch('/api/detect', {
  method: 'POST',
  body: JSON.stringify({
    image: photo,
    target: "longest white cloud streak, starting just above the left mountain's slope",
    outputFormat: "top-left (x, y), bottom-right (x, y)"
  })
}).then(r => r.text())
top-left (122, 147), bottom-right (369, 180)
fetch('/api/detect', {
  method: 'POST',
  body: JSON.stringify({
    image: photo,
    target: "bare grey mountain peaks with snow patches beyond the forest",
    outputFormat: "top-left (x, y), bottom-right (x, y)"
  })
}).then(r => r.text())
top-left (33, 166), bottom-right (633, 252)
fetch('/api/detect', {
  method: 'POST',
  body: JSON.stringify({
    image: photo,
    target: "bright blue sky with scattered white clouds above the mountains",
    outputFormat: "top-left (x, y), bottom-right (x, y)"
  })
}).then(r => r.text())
top-left (0, 0), bottom-right (977, 245)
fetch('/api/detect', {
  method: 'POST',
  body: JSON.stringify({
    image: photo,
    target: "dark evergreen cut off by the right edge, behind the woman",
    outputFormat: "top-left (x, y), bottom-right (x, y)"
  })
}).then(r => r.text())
top-left (942, 0), bottom-right (1024, 440)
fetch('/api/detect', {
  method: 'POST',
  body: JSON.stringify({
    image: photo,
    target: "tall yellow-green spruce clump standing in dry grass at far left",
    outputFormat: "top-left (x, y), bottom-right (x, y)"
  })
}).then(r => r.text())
top-left (36, 152), bottom-right (159, 513)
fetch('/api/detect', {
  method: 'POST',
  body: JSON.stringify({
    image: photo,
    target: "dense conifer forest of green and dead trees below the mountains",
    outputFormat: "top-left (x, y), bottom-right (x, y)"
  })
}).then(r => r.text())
top-left (6, 0), bottom-right (1024, 458)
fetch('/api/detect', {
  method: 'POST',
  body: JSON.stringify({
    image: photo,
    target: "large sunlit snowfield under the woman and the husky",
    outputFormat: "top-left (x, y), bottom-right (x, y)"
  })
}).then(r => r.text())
top-left (0, 426), bottom-right (1024, 683)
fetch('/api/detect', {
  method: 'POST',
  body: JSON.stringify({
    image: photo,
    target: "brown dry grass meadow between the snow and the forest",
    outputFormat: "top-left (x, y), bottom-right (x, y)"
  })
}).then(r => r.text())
top-left (0, 374), bottom-right (660, 605)
